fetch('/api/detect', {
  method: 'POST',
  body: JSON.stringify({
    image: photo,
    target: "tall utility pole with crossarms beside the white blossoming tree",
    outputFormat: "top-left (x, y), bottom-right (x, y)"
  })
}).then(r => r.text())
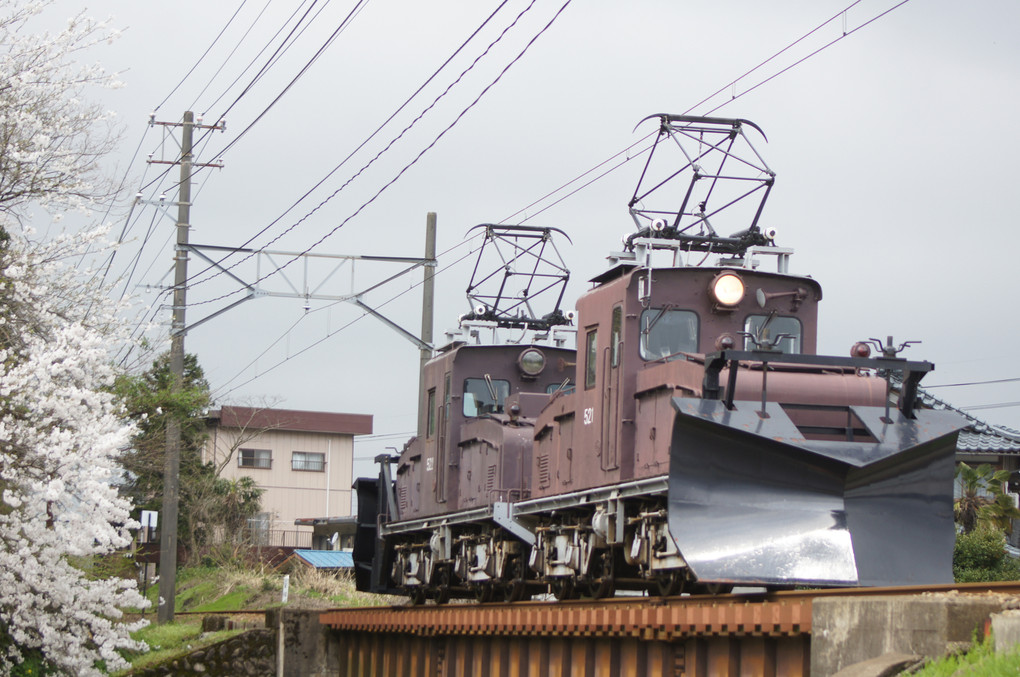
top-left (149, 110), bottom-right (225, 623)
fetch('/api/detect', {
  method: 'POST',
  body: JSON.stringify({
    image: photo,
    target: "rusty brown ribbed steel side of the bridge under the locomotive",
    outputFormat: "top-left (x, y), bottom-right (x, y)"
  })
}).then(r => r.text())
top-left (319, 582), bottom-right (1020, 677)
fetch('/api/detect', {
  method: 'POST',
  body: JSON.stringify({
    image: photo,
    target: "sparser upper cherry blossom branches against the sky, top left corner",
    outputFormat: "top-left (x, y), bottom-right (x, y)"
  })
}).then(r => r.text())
top-left (0, 0), bottom-right (119, 219)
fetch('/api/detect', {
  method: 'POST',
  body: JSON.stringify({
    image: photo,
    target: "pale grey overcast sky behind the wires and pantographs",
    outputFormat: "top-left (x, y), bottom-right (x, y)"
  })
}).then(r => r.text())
top-left (65, 0), bottom-right (1020, 487)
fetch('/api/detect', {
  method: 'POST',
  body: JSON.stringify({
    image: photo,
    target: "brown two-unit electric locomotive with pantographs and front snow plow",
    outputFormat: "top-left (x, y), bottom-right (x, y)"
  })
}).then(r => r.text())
top-left (354, 115), bottom-right (963, 604)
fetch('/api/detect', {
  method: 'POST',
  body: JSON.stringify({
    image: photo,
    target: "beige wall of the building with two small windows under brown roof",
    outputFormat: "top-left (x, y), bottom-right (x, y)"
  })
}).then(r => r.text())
top-left (205, 426), bottom-right (354, 533)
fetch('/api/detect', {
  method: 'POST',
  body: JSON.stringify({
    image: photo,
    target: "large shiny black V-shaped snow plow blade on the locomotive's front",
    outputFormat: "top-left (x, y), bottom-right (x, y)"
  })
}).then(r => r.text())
top-left (669, 398), bottom-right (966, 586)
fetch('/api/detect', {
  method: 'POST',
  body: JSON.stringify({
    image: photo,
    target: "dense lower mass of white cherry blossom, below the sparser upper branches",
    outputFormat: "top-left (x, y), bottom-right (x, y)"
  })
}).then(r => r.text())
top-left (0, 230), bottom-right (145, 675)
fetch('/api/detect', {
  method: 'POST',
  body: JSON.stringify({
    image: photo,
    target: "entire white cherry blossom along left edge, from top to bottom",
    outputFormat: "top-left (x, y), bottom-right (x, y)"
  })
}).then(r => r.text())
top-left (0, 0), bottom-right (145, 675)
